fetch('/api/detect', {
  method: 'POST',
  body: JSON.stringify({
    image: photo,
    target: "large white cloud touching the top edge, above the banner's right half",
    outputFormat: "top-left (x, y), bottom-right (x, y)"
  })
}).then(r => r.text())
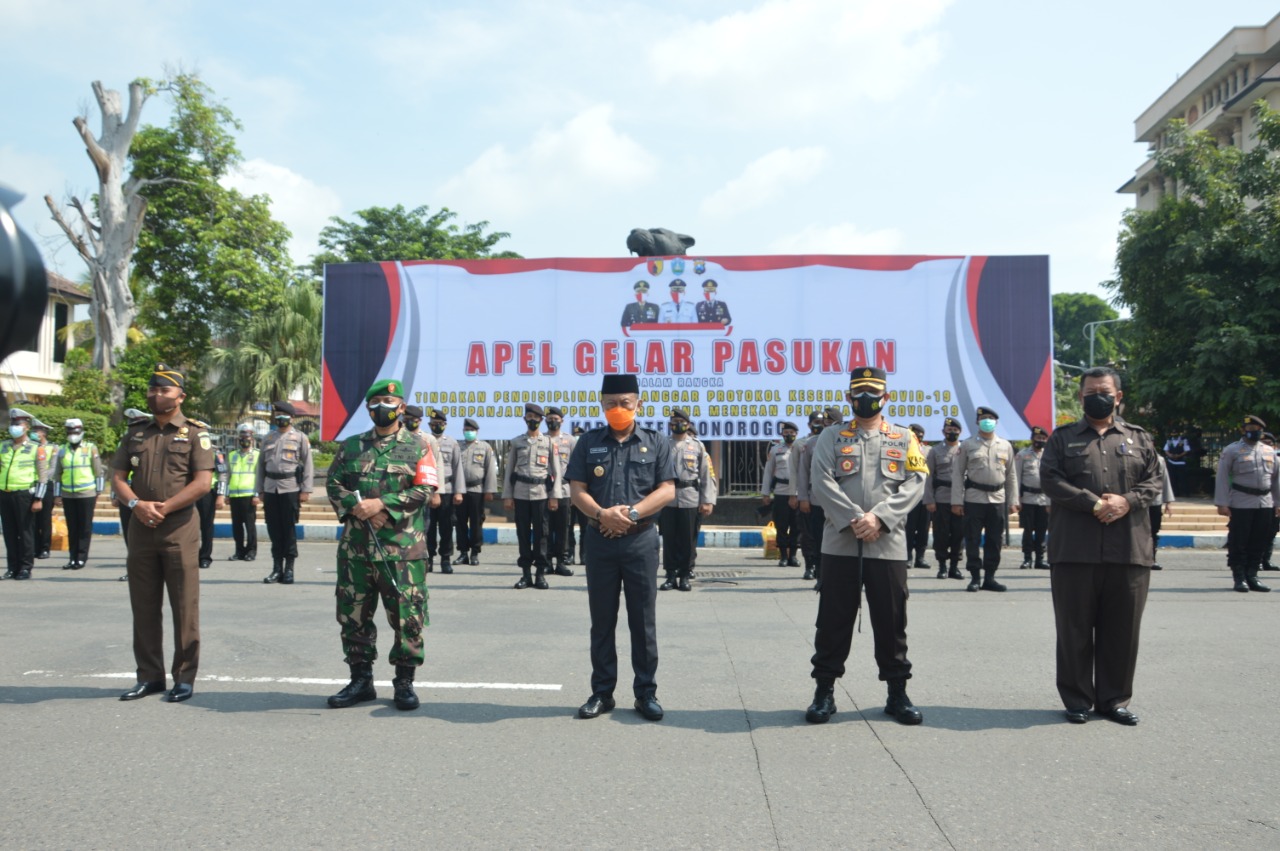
top-left (649, 0), bottom-right (951, 123)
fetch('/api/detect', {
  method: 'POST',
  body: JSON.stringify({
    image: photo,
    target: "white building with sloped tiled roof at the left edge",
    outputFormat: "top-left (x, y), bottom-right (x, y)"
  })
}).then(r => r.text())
top-left (0, 273), bottom-right (90, 404)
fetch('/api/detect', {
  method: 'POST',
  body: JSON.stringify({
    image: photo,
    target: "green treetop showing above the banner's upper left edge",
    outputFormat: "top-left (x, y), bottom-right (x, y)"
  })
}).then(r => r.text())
top-left (310, 203), bottom-right (520, 280)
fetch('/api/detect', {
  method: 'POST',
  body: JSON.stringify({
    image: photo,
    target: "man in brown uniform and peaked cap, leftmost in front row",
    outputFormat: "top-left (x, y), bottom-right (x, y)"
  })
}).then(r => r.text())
top-left (111, 363), bottom-right (214, 703)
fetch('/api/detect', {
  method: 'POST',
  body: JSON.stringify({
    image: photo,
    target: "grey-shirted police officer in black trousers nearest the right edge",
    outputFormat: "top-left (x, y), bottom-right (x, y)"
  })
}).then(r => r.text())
top-left (1213, 415), bottom-right (1280, 593)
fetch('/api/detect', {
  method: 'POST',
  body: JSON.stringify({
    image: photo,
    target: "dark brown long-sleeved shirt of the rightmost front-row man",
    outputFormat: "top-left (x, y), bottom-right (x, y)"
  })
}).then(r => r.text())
top-left (1041, 418), bottom-right (1164, 567)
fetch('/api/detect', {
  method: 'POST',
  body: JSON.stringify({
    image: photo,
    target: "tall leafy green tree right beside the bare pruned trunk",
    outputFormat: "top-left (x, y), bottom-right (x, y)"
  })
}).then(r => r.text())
top-left (129, 74), bottom-right (291, 380)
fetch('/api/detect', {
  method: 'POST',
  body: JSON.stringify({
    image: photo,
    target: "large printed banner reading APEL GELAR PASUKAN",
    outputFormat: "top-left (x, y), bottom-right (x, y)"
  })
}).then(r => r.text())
top-left (321, 256), bottom-right (1053, 440)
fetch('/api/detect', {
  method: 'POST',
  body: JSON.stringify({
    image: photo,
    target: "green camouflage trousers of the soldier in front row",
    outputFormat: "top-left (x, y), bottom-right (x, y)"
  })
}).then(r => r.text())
top-left (335, 549), bottom-right (431, 665)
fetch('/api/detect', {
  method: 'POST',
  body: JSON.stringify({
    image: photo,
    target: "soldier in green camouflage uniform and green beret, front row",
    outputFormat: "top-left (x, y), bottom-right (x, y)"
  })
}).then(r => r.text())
top-left (326, 379), bottom-right (438, 710)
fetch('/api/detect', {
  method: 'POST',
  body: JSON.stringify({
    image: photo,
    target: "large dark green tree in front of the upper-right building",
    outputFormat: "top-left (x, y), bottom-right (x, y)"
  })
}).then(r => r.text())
top-left (1108, 101), bottom-right (1280, 427)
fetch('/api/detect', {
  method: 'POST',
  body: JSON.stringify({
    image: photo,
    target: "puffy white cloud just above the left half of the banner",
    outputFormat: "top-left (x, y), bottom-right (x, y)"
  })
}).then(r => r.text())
top-left (439, 104), bottom-right (658, 219)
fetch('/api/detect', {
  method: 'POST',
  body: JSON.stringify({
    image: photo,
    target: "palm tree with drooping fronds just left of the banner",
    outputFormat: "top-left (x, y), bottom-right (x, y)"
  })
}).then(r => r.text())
top-left (206, 282), bottom-right (324, 418)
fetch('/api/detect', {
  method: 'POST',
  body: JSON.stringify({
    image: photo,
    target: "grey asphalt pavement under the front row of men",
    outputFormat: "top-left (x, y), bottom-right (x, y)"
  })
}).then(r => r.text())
top-left (0, 537), bottom-right (1280, 848)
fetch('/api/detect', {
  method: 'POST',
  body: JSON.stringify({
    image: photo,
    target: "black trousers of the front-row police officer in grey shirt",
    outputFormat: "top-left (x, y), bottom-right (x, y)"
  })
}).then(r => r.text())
top-left (813, 553), bottom-right (911, 680)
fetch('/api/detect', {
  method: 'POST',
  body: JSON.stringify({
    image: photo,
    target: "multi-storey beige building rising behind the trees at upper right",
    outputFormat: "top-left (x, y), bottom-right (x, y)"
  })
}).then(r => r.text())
top-left (1119, 14), bottom-right (1280, 210)
